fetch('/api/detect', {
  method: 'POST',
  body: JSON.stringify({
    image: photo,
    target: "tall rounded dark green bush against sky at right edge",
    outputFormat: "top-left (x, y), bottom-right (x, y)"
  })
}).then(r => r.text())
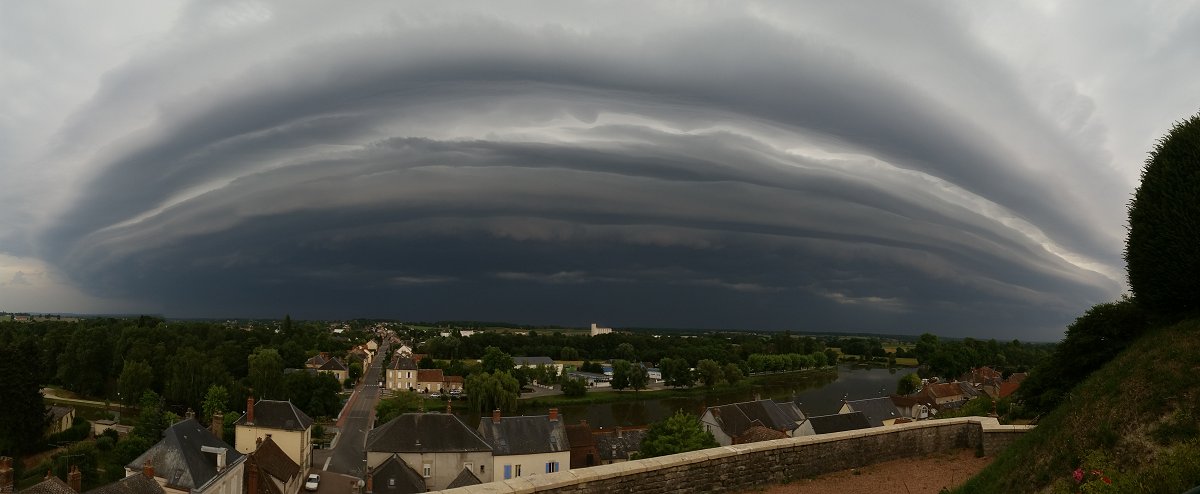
top-left (1124, 114), bottom-right (1200, 320)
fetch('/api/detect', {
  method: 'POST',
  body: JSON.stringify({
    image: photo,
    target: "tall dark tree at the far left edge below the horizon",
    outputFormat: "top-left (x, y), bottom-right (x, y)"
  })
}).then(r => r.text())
top-left (0, 342), bottom-right (47, 457)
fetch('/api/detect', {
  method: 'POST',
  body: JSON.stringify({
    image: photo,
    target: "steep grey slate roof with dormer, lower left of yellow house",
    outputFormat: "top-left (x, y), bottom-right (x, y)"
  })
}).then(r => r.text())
top-left (125, 418), bottom-right (242, 489)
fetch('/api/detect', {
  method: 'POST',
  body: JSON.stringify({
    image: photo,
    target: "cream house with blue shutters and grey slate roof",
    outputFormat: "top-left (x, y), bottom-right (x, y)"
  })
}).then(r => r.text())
top-left (478, 409), bottom-right (571, 480)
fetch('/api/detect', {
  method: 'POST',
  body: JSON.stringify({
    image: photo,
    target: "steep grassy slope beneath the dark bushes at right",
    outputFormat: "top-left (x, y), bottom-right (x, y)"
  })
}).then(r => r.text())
top-left (956, 319), bottom-right (1200, 493)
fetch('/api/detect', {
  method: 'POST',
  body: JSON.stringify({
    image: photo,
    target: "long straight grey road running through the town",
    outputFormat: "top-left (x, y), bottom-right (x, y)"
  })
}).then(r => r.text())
top-left (328, 345), bottom-right (388, 478)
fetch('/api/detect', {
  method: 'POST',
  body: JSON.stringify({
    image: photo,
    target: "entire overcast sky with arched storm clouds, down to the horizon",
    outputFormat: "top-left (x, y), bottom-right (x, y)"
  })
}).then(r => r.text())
top-left (0, 0), bottom-right (1200, 341)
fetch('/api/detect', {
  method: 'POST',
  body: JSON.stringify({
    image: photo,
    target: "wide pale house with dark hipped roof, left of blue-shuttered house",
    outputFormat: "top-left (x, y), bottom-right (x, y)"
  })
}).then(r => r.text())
top-left (366, 412), bottom-right (493, 490)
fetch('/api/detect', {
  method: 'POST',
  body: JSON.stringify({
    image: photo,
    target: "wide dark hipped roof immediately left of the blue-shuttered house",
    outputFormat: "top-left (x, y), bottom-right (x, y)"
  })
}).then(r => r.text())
top-left (367, 414), bottom-right (492, 453)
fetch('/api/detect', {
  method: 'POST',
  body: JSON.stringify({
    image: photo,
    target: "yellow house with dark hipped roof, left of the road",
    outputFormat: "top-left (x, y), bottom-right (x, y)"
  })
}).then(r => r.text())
top-left (234, 398), bottom-right (313, 471)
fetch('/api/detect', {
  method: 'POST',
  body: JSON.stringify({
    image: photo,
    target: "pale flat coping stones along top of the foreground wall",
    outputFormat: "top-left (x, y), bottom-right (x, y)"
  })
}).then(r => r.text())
top-left (440, 417), bottom-right (1034, 494)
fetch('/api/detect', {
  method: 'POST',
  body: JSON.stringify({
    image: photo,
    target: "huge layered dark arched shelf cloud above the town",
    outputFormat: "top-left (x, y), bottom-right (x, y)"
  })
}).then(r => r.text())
top-left (9, 0), bottom-right (1156, 339)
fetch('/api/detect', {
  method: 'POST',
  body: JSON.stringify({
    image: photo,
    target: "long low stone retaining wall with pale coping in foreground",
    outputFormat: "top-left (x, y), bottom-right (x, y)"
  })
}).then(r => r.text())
top-left (432, 417), bottom-right (1031, 494)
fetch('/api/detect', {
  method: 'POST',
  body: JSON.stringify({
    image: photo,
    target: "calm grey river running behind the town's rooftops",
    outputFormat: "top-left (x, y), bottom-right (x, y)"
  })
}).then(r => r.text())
top-left (453, 365), bottom-right (916, 428)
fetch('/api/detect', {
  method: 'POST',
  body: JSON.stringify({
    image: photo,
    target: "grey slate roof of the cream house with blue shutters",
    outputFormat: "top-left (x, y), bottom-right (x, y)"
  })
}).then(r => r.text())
top-left (479, 415), bottom-right (571, 456)
